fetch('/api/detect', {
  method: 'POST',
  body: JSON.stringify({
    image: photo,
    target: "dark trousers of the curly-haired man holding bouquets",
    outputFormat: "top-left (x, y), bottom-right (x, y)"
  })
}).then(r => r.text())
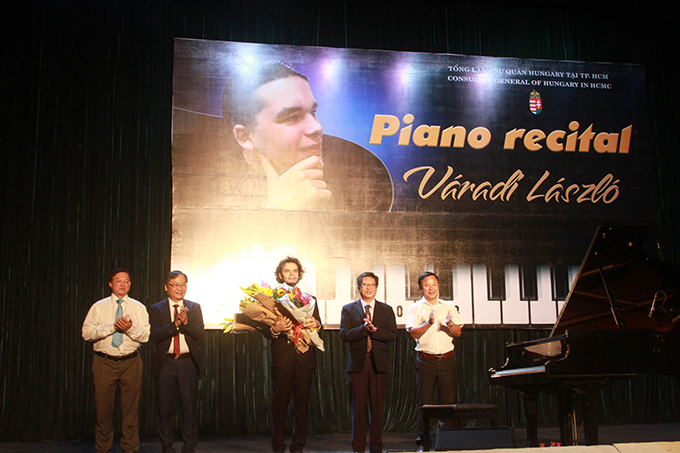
top-left (272, 364), bottom-right (314, 452)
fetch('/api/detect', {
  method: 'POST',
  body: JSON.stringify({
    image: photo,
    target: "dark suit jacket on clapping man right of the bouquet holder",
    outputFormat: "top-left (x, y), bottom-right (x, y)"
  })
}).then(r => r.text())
top-left (340, 300), bottom-right (397, 373)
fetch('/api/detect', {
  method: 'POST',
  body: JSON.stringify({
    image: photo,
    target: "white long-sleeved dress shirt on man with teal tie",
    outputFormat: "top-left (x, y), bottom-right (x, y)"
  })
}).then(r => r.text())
top-left (82, 294), bottom-right (151, 356)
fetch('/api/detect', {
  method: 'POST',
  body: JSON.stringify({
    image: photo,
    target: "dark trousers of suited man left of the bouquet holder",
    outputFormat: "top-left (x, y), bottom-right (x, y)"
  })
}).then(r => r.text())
top-left (156, 357), bottom-right (198, 453)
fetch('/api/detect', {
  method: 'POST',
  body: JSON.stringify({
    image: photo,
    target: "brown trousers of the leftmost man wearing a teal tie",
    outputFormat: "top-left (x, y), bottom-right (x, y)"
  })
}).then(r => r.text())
top-left (92, 355), bottom-right (144, 453)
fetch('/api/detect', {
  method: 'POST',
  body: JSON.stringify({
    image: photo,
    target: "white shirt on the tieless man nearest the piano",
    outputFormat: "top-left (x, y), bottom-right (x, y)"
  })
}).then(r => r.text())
top-left (406, 297), bottom-right (463, 355)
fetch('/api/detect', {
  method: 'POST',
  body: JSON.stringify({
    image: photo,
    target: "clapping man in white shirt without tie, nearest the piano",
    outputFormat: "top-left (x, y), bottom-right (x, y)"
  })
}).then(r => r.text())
top-left (406, 272), bottom-right (463, 451)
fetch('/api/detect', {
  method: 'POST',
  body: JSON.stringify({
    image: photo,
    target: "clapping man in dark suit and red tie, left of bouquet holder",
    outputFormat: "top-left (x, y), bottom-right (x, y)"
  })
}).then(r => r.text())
top-left (149, 271), bottom-right (205, 453)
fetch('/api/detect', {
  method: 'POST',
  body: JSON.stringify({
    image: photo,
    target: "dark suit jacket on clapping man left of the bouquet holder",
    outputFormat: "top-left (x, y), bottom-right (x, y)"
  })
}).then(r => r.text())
top-left (149, 299), bottom-right (205, 378)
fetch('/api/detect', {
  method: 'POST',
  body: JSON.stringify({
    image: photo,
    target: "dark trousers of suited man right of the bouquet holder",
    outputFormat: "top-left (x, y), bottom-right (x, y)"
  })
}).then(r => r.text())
top-left (347, 356), bottom-right (387, 452)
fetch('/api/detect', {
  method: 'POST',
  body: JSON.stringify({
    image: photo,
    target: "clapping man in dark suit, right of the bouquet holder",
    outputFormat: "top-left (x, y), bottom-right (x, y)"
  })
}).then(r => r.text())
top-left (340, 272), bottom-right (397, 453)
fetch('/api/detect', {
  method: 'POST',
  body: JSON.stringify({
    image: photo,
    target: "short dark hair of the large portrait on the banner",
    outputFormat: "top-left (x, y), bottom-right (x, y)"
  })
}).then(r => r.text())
top-left (222, 62), bottom-right (309, 129)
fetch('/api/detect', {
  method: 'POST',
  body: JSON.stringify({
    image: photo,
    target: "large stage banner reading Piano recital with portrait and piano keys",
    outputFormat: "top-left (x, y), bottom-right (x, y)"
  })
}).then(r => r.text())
top-left (172, 39), bottom-right (655, 328)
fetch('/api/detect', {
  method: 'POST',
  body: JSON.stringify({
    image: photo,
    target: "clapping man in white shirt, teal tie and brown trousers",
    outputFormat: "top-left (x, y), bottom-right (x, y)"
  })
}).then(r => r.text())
top-left (82, 269), bottom-right (150, 453)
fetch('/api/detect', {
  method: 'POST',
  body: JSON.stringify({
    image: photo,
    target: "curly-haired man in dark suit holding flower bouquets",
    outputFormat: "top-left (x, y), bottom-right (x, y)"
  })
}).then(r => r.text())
top-left (263, 256), bottom-right (323, 453)
